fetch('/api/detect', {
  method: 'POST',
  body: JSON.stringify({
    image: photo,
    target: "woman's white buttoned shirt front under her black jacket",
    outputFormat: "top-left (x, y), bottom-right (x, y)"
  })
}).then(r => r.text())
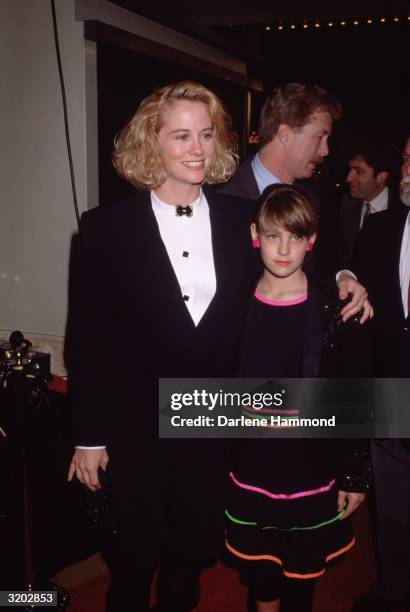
top-left (151, 190), bottom-right (216, 325)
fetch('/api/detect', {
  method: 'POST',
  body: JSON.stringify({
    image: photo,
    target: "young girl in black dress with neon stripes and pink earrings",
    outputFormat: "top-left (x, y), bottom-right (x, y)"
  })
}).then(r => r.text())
top-left (226, 184), bottom-right (369, 612)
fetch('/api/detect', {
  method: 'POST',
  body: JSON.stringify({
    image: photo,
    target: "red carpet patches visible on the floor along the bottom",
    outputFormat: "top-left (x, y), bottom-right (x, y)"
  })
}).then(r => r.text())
top-left (70, 505), bottom-right (376, 612)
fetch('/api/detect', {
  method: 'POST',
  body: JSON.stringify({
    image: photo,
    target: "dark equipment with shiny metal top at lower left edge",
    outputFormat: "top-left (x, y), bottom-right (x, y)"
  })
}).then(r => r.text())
top-left (0, 331), bottom-right (69, 611)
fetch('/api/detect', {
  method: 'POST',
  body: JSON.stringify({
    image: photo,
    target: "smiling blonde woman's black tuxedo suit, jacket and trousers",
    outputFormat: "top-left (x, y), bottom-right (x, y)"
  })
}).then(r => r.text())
top-left (70, 189), bottom-right (258, 565)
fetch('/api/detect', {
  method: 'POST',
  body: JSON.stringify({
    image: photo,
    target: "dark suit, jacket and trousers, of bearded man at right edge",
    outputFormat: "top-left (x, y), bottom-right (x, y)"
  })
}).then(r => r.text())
top-left (353, 205), bottom-right (410, 609)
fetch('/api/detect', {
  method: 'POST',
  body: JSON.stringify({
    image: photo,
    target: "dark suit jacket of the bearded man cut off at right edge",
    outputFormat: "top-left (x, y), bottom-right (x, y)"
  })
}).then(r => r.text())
top-left (353, 205), bottom-right (410, 378)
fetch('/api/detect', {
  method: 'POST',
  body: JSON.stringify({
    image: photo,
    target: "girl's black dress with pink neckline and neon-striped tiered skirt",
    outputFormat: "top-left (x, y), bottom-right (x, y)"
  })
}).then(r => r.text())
top-left (225, 292), bottom-right (368, 580)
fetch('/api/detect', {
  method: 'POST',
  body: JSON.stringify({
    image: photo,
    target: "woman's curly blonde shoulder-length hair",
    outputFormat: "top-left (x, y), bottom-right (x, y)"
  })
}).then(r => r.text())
top-left (113, 81), bottom-right (238, 189)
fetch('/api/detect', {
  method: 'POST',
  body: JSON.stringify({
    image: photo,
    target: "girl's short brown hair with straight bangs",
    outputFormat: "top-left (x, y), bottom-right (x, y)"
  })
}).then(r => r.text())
top-left (255, 183), bottom-right (319, 238)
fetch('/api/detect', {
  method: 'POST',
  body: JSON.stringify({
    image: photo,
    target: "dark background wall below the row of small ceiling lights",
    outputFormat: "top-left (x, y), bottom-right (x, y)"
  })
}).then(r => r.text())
top-left (262, 23), bottom-right (410, 170)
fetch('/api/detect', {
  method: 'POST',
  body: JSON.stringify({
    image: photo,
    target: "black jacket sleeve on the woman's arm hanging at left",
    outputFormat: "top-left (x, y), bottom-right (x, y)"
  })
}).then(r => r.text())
top-left (68, 211), bottom-right (115, 446)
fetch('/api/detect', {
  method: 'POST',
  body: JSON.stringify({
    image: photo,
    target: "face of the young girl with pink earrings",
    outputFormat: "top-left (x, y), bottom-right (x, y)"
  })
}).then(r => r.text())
top-left (251, 223), bottom-right (316, 278)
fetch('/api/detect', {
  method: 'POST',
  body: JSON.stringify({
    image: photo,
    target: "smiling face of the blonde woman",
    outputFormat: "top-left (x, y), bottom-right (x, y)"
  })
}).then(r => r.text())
top-left (158, 100), bottom-right (215, 188)
